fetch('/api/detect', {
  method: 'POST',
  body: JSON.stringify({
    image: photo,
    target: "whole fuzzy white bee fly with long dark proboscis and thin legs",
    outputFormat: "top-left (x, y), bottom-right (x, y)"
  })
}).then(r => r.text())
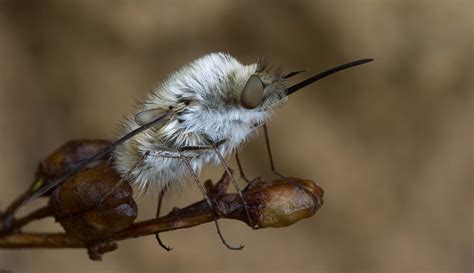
top-left (3, 53), bottom-right (371, 249)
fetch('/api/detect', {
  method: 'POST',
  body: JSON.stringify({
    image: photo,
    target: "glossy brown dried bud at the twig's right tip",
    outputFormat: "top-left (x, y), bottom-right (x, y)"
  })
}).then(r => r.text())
top-left (241, 178), bottom-right (324, 228)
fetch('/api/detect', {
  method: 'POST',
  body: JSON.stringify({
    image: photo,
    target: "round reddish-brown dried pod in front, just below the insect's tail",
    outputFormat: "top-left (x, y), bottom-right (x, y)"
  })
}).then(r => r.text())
top-left (49, 163), bottom-right (137, 241)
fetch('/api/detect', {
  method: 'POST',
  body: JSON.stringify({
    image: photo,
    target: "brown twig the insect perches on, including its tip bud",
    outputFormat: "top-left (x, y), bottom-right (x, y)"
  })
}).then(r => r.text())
top-left (0, 174), bottom-right (323, 260)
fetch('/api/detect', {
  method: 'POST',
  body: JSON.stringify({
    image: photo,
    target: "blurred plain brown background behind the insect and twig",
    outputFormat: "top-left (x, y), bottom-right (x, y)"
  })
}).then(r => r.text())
top-left (0, 0), bottom-right (474, 272)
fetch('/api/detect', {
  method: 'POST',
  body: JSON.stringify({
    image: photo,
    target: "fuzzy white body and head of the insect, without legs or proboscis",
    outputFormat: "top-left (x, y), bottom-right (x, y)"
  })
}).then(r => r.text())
top-left (113, 53), bottom-right (287, 192)
